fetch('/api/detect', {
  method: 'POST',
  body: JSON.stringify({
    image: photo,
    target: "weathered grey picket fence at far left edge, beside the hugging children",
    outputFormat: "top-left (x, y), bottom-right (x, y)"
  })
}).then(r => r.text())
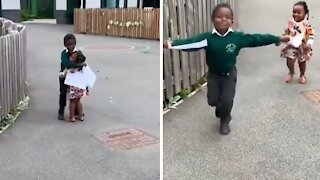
top-left (0, 19), bottom-right (27, 121)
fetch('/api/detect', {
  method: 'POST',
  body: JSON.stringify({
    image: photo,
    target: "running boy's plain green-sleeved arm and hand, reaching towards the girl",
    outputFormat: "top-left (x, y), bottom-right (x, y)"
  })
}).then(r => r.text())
top-left (241, 33), bottom-right (290, 48)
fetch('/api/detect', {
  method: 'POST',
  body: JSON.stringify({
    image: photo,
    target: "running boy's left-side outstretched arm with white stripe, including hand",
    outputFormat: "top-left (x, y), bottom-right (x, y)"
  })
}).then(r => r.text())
top-left (163, 33), bottom-right (208, 51)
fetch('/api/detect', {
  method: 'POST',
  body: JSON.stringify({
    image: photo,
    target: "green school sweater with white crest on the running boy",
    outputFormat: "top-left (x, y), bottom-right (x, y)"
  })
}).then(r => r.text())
top-left (172, 32), bottom-right (280, 73)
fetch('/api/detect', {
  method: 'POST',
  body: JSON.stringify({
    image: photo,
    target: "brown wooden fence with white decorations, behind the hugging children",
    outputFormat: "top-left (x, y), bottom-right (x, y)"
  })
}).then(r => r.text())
top-left (74, 8), bottom-right (160, 40)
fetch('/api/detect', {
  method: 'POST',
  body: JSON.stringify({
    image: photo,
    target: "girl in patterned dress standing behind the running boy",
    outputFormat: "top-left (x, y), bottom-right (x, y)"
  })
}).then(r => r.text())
top-left (281, 1), bottom-right (314, 84)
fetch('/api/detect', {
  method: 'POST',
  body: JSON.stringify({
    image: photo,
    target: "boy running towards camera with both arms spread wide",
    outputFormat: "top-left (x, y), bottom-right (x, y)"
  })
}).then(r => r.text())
top-left (163, 3), bottom-right (290, 134)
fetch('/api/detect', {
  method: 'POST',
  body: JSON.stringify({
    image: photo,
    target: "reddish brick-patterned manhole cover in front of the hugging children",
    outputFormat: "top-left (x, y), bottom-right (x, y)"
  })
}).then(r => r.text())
top-left (96, 129), bottom-right (158, 150)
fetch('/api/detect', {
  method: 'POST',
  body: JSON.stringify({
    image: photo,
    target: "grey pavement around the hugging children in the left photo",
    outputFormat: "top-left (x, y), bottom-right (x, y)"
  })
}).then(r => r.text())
top-left (0, 24), bottom-right (160, 180)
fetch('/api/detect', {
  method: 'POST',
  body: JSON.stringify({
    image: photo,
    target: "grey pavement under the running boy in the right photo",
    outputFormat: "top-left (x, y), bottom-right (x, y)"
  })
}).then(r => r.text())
top-left (164, 0), bottom-right (320, 180)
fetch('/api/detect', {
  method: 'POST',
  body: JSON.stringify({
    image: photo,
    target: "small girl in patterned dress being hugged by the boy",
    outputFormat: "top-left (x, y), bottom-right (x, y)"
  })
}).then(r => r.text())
top-left (68, 51), bottom-right (86, 122)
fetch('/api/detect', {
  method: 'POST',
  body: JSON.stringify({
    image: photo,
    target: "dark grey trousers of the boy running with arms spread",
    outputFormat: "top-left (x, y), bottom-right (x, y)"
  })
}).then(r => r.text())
top-left (207, 67), bottom-right (237, 124)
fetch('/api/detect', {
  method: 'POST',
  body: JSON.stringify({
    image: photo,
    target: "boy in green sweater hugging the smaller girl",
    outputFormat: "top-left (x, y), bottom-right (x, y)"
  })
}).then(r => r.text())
top-left (58, 34), bottom-right (86, 120)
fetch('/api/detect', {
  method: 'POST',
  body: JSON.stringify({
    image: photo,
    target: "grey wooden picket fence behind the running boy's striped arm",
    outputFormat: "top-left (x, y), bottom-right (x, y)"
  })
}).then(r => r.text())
top-left (163, 0), bottom-right (235, 103)
